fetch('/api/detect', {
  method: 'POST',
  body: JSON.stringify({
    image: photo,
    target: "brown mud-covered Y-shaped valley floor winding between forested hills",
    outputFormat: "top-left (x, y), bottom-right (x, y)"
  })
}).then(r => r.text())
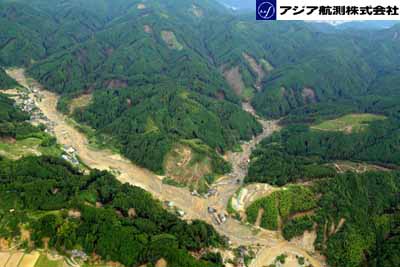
top-left (7, 69), bottom-right (322, 267)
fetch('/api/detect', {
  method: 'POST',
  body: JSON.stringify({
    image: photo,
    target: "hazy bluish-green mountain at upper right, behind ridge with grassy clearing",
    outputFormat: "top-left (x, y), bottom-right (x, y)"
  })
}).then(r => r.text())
top-left (253, 25), bottom-right (399, 116)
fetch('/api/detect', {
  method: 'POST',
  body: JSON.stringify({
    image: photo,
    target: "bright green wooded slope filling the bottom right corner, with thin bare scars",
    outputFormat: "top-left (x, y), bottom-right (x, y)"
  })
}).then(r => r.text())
top-left (246, 172), bottom-right (400, 267)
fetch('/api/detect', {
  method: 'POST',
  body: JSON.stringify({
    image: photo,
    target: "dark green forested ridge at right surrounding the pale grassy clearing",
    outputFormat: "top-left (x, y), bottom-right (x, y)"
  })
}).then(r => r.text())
top-left (246, 94), bottom-right (400, 185)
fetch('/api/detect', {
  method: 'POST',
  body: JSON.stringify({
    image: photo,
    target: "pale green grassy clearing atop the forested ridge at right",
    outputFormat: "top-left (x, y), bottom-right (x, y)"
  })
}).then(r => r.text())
top-left (311, 114), bottom-right (386, 133)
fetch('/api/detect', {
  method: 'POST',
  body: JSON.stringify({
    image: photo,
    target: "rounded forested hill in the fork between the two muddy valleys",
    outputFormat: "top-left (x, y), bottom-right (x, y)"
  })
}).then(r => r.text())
top-left (74, 86), bottom-right (261, 173)
